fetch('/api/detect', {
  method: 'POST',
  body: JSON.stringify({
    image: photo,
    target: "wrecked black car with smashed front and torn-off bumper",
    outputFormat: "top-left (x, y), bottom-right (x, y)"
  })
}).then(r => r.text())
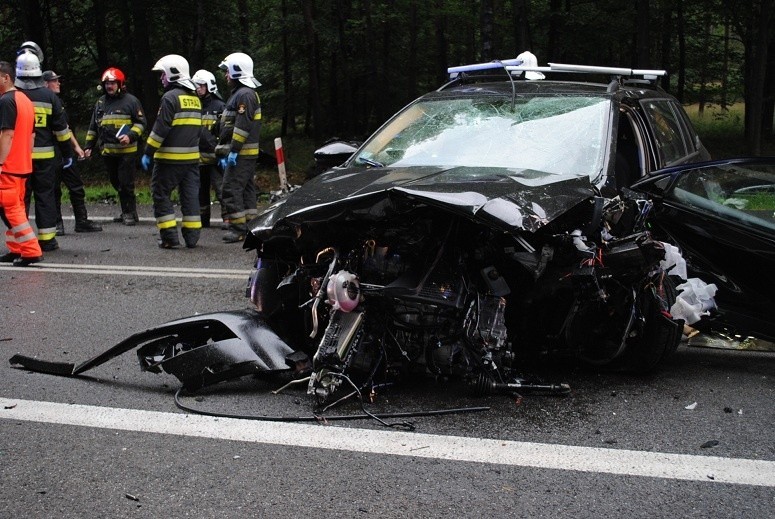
top-left (12, 62), bottom-right (775, 416)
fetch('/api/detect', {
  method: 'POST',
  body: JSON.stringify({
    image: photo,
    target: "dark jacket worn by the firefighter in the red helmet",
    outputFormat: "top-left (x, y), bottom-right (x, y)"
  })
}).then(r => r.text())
top-left (84, 92), bottom-right (147, 156)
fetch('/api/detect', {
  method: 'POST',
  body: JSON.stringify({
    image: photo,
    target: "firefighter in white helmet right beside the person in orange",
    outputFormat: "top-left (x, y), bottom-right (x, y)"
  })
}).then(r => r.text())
top-left (15, 52), bottom-right (73, 252)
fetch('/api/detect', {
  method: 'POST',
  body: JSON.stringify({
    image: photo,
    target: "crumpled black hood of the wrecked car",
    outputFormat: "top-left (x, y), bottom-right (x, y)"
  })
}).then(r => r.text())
top-left (249, 167), bottom-right (596, 235)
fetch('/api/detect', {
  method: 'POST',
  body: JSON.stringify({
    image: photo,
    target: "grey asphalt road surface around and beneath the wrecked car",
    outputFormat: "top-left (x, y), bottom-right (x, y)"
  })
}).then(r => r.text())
top-left (0, 206), bottom-right (775, 518)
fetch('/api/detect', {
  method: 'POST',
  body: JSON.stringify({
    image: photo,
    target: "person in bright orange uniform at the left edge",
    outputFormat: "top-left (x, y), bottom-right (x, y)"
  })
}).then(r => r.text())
top-left (0, 61), bottom-right (43, 267)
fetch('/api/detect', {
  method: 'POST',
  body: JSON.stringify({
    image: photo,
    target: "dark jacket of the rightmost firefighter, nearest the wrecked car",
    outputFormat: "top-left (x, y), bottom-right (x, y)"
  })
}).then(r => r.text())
top-left (215, 85), bottom-right (261, 159)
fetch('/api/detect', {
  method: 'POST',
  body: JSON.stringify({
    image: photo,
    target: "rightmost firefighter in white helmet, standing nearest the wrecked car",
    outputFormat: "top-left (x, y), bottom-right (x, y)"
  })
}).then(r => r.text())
top-left (216, 52), bottom-right (261, 243)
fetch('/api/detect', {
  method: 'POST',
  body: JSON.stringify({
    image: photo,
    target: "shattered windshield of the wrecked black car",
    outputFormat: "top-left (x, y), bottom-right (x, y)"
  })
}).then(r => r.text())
top-left (352, 96), bottom-right (610, 179)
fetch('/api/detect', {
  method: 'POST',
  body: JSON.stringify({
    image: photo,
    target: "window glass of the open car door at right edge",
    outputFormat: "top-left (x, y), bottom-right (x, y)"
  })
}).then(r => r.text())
top-left (668, 164), bottom-right (775, 232)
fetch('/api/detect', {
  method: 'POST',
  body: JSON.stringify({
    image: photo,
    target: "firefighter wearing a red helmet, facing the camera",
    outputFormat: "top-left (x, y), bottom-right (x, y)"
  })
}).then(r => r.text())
top-left (83, 67), bottom-right (146, 225)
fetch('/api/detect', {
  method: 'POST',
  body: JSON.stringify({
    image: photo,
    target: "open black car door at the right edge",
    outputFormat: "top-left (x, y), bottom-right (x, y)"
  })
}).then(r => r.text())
top-left (632, 158), bottom-right (775, 341)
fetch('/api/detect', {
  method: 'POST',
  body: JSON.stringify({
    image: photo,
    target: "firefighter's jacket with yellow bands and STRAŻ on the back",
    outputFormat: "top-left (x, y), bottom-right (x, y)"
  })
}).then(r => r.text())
top-left (145, 84), bottom-right (202, 164)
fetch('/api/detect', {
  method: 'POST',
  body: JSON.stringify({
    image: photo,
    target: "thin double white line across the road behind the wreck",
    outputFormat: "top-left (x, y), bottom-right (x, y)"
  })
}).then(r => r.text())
top-left (0, 261), bottom-right (250, 279)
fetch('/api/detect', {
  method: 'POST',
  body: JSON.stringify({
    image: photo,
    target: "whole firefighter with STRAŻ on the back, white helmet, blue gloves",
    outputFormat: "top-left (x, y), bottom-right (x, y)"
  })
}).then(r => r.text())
top-left (141, 54), bottom-right (202, 249)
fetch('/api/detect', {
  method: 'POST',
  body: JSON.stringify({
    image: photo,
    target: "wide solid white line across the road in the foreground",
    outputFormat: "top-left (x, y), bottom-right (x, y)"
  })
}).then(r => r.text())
top-left (0, 398), bottom-right (775, 487)
